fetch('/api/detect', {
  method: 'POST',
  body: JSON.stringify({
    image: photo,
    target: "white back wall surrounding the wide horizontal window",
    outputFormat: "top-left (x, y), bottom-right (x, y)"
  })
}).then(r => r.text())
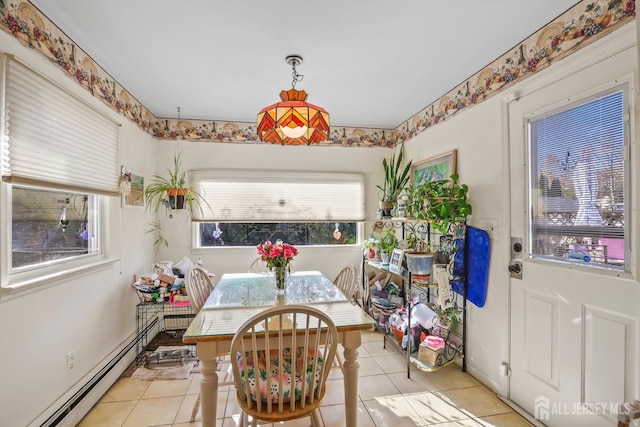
top-left (152, 141), bottom-right (391, 279)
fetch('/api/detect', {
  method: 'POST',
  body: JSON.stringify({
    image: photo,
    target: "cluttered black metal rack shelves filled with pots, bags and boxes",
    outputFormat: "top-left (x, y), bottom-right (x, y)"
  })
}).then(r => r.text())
top-left (363, 218), bottom-right (467, 375)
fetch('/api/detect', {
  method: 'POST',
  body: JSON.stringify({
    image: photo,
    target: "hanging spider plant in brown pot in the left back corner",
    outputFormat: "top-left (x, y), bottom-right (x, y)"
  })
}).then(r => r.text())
top-left (144, 153), bottom-right (207, 214)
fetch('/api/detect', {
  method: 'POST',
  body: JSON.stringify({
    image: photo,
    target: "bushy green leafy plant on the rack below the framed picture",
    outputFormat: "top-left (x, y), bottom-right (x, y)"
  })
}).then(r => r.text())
top-left (420, 173), bottom-right (472, 234)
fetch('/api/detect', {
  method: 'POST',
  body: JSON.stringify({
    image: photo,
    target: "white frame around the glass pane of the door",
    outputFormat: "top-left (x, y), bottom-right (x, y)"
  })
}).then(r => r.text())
top-left (523, 80), bottom-right (636, 277)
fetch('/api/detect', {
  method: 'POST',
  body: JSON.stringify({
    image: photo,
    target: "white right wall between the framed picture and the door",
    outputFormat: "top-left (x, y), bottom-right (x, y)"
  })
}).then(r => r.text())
top-left (405, 93), bottom-right (509, 390)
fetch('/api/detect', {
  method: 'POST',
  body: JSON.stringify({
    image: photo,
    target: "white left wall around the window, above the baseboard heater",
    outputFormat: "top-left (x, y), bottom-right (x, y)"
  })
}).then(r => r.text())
top-left (0, 32), bottom-right (156, 426)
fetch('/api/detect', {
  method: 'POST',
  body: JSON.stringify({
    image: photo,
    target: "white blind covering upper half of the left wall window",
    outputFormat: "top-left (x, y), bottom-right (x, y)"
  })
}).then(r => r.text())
top-left (2, 56), bottom-right (119, 195)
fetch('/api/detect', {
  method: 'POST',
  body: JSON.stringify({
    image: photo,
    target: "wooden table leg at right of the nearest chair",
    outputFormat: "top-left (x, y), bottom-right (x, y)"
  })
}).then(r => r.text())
top-left (342, 331), bottom-right (361, 427)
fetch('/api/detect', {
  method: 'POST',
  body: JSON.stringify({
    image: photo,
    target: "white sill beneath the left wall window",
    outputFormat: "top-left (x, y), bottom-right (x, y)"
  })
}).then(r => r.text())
top-left (0, 258), bottom-right (118, 302)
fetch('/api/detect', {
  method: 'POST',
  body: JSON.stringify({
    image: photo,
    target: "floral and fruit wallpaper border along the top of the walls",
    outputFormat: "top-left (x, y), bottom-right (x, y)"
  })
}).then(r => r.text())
top-left (0, 0), bottom-right (635, 147)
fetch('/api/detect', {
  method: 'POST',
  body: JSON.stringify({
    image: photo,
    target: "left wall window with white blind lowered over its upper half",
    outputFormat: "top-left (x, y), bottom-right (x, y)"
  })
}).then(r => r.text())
top-left (0, 56), bottom-right (119, 289)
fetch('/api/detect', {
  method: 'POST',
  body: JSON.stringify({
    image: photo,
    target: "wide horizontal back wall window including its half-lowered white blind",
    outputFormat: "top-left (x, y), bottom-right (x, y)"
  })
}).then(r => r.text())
top-left (192, 170), bottom-right (364, 247)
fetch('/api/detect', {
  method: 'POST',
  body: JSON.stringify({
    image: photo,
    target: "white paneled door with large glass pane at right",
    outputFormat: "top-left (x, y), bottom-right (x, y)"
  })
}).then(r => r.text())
top-left (508, 39), bottom-right (640, 426)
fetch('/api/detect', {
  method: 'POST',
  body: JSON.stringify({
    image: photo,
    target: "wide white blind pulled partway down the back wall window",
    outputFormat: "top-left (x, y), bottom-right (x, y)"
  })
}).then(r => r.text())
top-left (191, 170), bottom-right (364, 222)
